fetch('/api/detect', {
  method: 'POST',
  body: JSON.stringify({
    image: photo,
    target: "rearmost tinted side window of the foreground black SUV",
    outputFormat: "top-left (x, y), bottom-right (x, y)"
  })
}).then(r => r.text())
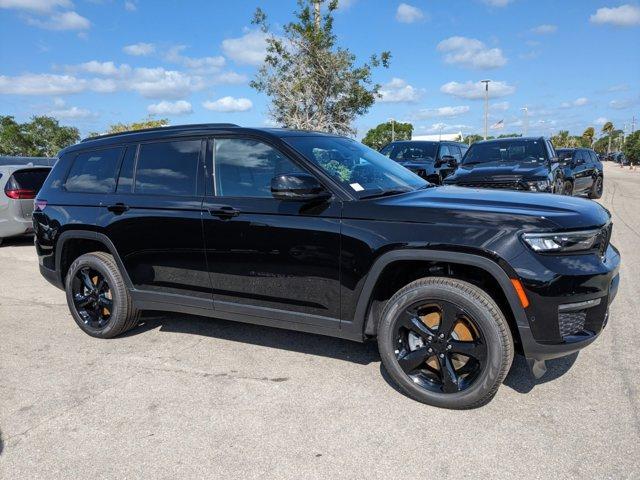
top-left (64, 147), bottom-right (122, 193)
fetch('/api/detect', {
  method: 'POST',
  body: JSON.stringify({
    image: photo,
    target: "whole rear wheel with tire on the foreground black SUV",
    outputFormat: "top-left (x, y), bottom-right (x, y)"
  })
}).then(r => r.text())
top-left (65, 252), bottom-right (138, 338)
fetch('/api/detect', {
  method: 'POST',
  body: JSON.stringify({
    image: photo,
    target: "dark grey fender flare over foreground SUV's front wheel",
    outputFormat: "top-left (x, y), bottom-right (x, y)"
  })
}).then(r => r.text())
top-left (343, 249), bottom-right (531, 341)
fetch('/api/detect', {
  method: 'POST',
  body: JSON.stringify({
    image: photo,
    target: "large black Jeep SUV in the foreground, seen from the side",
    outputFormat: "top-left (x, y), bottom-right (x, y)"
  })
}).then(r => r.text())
top-left (33, 124), bottom-right (620, 408)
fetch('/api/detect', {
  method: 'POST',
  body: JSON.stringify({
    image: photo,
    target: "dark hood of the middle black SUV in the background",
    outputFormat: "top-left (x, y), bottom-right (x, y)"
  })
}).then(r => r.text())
top-left (447, 162), bottom-right (549, 183)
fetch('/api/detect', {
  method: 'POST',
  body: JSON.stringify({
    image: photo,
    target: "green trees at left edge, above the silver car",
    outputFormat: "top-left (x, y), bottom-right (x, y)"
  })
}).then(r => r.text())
top-left (0, 115), bottom-right (80, 157)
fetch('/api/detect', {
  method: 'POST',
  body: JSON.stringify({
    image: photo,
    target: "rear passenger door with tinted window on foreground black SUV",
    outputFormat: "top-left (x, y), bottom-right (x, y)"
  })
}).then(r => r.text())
top-left (99, 138), bottom-right (212, 309)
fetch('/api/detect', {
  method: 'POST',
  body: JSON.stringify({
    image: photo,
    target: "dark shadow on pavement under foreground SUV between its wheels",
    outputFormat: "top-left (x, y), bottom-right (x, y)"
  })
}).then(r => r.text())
top-left (127, 312), bottom-right (380, 365)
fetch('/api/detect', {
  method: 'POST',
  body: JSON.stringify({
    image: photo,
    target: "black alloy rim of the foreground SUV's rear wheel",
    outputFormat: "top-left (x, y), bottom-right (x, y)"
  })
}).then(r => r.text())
top-left (71, 266), bottom-right (113, 330)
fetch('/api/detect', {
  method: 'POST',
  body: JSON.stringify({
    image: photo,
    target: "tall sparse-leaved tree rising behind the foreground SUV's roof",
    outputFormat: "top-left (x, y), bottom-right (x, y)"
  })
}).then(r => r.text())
top-left (251, 0), bottom-right (391, 134)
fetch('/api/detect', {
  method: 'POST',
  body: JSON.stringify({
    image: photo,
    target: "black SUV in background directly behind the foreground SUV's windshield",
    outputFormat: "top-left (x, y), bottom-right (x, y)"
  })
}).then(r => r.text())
top-left (380, 140), bottom-right (469, 185)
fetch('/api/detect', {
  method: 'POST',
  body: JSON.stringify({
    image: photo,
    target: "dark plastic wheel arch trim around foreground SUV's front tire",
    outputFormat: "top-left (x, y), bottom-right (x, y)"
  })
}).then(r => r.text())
top-left (352, 249), bottom-right (529, 346)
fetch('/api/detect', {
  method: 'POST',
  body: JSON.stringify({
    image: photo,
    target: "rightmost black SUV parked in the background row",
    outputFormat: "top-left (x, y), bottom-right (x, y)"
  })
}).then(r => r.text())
top-left (556, 148), bottom-right (604, 198)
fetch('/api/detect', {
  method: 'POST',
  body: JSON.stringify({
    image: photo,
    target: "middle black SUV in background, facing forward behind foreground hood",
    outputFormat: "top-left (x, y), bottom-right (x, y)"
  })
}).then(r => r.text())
top-left (445, 137), bottom-right (564, 194)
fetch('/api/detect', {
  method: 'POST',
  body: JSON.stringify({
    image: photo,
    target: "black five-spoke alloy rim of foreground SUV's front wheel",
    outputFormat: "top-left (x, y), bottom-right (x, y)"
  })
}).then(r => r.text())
top-left (395, 300), bottom-right (487, 393)
